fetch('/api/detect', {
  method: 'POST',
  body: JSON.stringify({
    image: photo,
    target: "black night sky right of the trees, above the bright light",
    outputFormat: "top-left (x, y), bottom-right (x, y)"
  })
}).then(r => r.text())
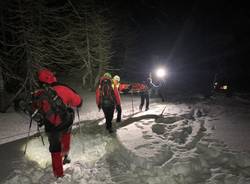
top-left (102, 0), bottom-right (250, 90)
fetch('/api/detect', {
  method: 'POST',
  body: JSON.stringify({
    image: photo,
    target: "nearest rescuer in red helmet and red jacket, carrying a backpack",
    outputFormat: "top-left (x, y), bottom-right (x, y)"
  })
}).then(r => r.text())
top-left (33, 69), bottom-right (82, 177)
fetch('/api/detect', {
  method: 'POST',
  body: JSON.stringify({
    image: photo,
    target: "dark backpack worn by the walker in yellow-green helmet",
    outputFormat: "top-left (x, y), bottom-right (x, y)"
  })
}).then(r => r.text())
top-left (100, 79), bottom-right (115, 107)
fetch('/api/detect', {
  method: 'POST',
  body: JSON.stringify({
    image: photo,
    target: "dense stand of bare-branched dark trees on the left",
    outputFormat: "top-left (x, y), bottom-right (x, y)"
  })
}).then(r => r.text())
top-left (0, 0), bottom-right (115, 109)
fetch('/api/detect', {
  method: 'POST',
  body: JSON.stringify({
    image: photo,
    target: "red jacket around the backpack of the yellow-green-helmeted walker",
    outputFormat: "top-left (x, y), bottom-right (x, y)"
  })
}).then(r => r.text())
top-left (96, 77), bottom-right (121, 107)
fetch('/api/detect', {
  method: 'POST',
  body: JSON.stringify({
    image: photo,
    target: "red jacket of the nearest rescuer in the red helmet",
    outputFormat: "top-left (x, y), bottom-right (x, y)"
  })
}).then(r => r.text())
top-left (33, 85), bottom-right (82, 126)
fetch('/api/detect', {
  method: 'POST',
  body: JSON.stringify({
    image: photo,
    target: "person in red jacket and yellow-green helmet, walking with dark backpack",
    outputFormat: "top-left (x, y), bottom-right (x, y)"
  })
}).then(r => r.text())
top-left (96, 73), bottom-right (121, 133)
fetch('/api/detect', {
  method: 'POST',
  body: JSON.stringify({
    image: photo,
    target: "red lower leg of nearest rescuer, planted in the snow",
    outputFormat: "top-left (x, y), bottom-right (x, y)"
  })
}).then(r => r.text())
top-left (51, 152), bottom-right (64, 178)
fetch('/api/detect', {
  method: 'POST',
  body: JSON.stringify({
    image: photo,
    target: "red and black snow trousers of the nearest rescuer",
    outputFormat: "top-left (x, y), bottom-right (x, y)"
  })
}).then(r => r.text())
top-left (47, 131), bottom-right (71, 177)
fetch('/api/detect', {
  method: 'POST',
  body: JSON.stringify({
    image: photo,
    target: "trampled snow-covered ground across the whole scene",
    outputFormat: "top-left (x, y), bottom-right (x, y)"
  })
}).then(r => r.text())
top-left (0, 88), bottom-right (250, 184)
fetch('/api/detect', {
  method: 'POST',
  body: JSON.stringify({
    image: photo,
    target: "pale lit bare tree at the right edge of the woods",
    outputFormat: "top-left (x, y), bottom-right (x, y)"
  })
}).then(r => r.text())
top-left (66, 1), bottom-right (113, 89)
